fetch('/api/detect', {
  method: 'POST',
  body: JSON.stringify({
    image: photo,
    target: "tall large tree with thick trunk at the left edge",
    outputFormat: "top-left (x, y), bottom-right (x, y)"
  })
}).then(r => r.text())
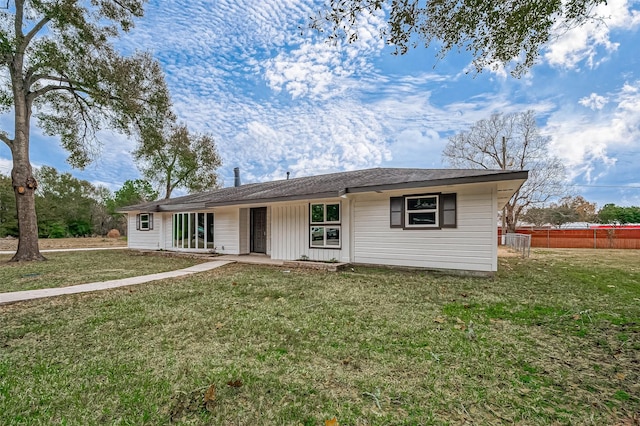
top-left (0, 0), bottom-right (169, 260)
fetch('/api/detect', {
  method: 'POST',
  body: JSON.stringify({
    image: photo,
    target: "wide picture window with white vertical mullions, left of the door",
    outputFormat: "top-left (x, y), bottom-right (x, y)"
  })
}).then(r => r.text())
top-left (172, 213), bottom-right (215, 250)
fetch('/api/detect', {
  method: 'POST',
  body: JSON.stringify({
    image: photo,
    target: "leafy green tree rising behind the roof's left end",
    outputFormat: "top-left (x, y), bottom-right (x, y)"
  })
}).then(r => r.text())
top-left (134, 121), bottom-right (222, 198)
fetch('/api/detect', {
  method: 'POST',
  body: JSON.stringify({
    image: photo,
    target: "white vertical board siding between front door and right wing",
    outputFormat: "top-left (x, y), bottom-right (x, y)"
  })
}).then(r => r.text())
top-left (270, 200), bottom-right (348, 261)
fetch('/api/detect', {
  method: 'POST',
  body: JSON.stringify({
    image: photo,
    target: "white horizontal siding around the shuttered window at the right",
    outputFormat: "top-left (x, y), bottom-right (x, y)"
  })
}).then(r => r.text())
top-left (353, 184), bottom-right (497, 272)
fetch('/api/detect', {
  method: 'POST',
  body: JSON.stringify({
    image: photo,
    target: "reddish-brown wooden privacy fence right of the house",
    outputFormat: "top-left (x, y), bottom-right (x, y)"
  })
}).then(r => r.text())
top-left (498, 228), bottom-right (640, 249)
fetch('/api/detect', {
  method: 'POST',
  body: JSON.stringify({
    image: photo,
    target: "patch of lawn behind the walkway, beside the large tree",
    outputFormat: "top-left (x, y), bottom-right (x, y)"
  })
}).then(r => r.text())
top-left (0, 250), bottom-right (201, 293)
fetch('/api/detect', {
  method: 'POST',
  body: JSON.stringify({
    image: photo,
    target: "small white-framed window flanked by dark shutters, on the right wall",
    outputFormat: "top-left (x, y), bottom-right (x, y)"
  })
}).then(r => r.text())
top-left (389, 194), bottom-right (457, 229)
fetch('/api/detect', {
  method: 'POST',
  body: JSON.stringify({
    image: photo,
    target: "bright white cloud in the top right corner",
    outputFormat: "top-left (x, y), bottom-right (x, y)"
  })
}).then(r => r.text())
top-left (544, 0), bottom-right (640, 69)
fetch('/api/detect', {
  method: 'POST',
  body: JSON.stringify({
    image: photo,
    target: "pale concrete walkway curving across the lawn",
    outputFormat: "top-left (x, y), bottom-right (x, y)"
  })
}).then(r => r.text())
top-left (0, 258), bottom-right (234, 305)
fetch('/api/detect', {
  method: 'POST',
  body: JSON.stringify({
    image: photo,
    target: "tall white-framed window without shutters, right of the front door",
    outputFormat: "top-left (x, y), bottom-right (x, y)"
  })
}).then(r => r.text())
top-left (309, 203), bottom-right (341, 248)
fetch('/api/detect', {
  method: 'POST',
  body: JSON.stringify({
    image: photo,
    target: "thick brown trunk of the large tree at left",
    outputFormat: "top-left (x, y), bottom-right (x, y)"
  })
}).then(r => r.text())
top-left (11, 87), bottom-right (45, 262)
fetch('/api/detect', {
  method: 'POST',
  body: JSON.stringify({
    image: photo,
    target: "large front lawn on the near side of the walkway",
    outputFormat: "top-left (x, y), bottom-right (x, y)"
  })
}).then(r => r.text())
top-left (0, 251), bottom-right (640, 425)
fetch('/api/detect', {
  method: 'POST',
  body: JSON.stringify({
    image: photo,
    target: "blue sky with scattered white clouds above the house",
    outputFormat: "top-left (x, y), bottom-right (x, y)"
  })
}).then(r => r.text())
top-left (0, 0), bottom-right (640, 206)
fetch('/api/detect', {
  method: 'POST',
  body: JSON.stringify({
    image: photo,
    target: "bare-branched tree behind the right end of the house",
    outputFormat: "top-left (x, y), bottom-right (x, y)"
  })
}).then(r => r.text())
top-left (442, 111), bottom-right (566, 232)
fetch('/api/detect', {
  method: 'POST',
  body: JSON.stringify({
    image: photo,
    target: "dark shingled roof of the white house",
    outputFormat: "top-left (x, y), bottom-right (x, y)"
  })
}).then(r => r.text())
top-left (120, 168), bottom-right (528, 212)
